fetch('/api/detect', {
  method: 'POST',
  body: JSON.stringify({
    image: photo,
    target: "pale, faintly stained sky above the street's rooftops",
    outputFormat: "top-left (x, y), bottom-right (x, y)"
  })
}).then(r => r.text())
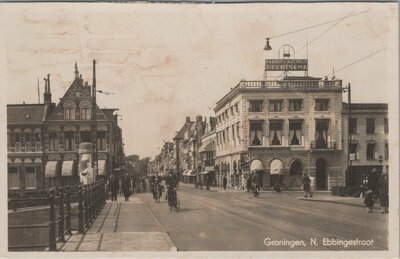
top-left (0, 3), bottom-right (398, 157)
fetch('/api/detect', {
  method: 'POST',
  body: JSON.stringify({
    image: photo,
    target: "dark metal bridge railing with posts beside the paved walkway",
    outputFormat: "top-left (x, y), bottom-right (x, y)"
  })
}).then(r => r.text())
top-left (8, 180), bottom-right (107, 251)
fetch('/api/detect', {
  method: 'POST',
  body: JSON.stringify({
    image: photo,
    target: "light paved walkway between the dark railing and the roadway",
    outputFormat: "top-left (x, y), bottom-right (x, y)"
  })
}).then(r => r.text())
top-left (59, 197), bottom-right (176, 252)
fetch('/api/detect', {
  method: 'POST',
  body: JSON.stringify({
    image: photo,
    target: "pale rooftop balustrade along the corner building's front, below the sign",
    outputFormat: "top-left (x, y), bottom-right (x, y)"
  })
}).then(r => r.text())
top-left (240, 80), bottom-right (342, 88)
